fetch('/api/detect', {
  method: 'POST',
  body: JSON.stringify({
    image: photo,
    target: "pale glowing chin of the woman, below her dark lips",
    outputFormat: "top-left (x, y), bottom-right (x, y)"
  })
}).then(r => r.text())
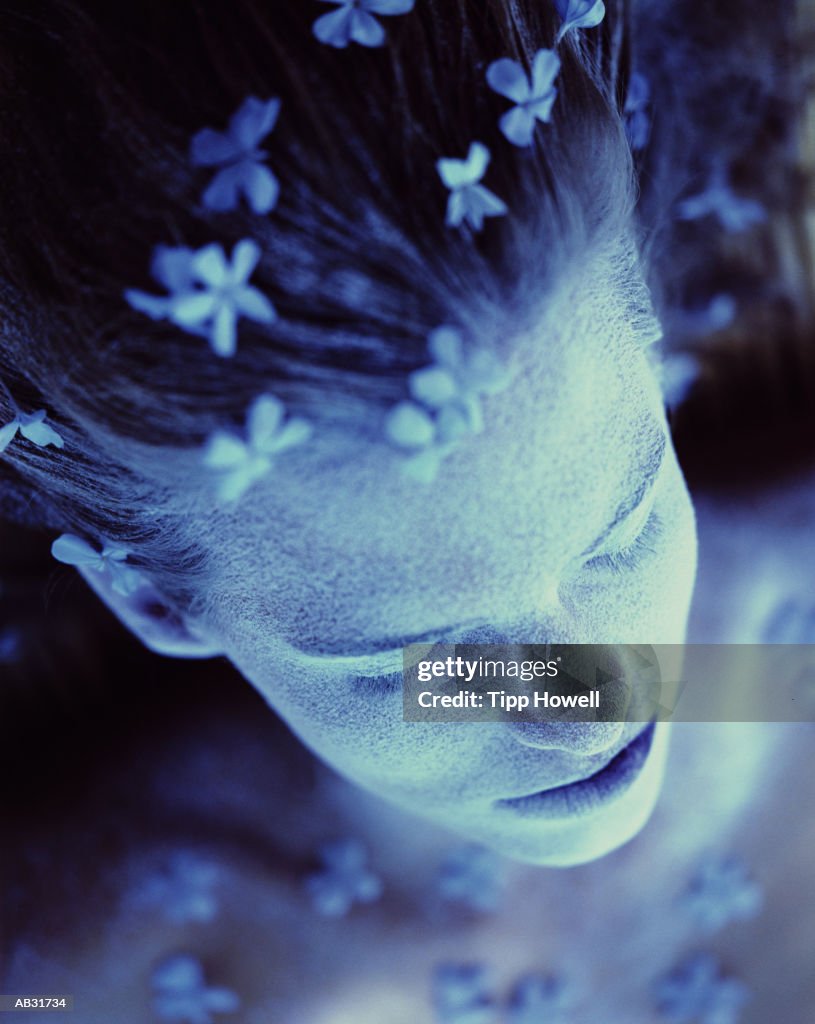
top-left (454, 723), bottom-right (670, 867)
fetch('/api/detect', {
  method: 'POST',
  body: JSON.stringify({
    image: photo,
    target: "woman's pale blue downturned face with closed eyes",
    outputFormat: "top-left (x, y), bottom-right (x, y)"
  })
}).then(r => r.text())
top-left (189, 280), bottom-right (696, 864)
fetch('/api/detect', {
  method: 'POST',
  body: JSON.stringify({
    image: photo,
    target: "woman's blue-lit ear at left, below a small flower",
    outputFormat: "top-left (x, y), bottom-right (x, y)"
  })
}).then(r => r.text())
top-left (79, 566), bottom-right (223, 658)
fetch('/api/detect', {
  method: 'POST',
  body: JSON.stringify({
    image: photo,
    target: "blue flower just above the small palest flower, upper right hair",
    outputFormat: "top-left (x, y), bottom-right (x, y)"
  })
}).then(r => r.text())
top-left (486, 50), bottom-right (560, 145)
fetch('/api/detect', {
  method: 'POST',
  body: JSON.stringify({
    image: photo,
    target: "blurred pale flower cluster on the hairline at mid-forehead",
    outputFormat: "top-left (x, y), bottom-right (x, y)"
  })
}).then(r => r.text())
top-left (385, 327), bottom-right (509, 483)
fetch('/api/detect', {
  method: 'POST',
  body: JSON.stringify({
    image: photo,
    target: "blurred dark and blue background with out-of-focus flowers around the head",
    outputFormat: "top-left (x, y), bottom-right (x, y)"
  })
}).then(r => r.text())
top-left (0, 0), bottom-right (815, 1024)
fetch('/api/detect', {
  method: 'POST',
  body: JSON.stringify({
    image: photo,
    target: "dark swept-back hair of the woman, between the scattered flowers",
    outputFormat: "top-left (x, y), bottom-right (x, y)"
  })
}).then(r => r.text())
top-left (0, 0), bottom-right (636, 600)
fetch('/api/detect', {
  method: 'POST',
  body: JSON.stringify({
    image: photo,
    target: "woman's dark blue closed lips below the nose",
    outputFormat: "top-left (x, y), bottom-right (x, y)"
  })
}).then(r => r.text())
top-left (496, 722), bottom-right (655, 819)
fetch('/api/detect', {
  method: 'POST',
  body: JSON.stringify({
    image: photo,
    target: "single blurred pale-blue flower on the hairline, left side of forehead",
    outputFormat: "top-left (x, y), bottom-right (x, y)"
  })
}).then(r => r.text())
top-left (204, 394), bottom-right (311, 503)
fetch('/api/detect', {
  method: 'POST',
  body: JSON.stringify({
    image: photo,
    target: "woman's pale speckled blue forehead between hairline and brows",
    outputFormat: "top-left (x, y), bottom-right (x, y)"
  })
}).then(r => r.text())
top-left (206, 280), bottom-right (664, 647)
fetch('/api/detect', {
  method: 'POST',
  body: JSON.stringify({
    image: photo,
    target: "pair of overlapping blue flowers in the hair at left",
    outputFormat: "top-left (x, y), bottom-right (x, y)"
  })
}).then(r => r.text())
top-left (125, 239), bottom-right (277, 356)
